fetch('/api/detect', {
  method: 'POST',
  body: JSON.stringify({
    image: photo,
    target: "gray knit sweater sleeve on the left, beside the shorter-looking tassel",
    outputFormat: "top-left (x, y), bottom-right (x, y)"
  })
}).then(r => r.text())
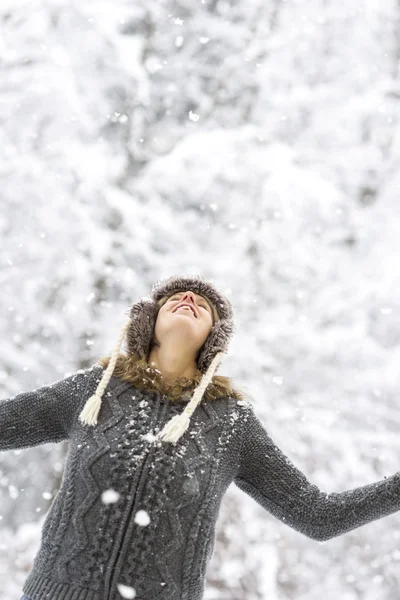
top-left (0, 365), bottom-right (99, 450)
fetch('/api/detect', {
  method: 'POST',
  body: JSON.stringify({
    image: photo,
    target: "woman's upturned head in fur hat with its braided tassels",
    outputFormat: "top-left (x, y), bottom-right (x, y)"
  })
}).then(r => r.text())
top-left (83, 276), bottom-right (252, 444)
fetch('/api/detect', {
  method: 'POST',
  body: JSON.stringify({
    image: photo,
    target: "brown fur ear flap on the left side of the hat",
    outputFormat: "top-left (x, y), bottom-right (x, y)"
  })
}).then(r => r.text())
top-left (126, 298), bottom-right (159, 358)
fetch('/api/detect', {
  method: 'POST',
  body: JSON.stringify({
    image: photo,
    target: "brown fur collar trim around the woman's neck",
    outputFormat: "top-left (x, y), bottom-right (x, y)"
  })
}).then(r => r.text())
top-left (97, 354), bottom-right (243, 403)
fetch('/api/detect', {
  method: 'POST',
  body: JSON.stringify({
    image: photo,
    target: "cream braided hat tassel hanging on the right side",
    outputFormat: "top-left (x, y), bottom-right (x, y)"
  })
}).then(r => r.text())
top-left (156, 352), bottom-right (223, 445)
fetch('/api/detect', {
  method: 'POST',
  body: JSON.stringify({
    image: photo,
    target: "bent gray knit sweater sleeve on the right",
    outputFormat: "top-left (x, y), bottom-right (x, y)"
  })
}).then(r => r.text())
top-left (234, 407), bottom-right (400, 541)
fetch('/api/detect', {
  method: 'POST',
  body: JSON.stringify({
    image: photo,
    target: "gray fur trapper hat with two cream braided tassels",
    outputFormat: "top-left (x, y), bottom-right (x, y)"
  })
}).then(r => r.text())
top-left (79, 275), bottom-right (235, 444)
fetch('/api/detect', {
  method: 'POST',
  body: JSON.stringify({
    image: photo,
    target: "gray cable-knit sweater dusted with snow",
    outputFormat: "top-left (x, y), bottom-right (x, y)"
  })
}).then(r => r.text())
top-left (0, 365), bottom-right (400, 600)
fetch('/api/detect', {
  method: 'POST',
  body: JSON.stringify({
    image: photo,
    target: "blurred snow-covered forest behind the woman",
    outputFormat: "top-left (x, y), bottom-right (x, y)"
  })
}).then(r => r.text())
top-left (0, 0), bottom-right (400, 600)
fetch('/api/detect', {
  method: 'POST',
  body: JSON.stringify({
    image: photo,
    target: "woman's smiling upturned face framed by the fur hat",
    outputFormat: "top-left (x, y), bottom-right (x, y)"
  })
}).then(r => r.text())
top-left (154, 290), bottom-right (214, 355)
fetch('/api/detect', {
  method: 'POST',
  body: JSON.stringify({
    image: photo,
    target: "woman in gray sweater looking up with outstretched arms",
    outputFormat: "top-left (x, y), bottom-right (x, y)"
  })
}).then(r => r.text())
top-left (0, 276), bottom-right (400, 600)
